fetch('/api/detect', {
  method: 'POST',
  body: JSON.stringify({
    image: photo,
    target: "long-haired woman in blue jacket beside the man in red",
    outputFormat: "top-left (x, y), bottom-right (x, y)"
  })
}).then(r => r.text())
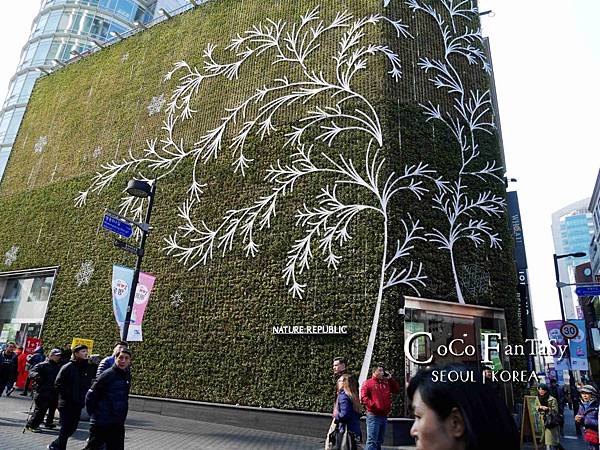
top-left (327, 373), bottom-right (362, 450)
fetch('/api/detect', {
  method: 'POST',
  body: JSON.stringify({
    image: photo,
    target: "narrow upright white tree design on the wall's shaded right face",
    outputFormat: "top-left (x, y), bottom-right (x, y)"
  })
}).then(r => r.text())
top-left (406, 0), bottom-right (505, 303)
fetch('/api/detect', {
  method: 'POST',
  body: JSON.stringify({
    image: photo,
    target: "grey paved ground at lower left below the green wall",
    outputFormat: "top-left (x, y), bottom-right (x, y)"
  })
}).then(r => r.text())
top-left (0, 394), bottom-right (414, 450)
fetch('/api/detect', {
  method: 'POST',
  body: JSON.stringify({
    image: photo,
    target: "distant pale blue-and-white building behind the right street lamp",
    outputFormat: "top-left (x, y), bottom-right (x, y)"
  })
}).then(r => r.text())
top-left (552, 198), bottom-right (594, 319)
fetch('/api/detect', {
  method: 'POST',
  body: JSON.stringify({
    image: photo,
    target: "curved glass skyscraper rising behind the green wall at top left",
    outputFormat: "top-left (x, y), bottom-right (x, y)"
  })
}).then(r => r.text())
top-left (0, 0), bottom-right (157, 180)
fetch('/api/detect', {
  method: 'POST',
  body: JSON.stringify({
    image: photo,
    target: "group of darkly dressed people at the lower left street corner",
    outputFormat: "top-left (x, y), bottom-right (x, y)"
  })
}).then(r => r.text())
top-left (0, 342), bottom-right (131, 450)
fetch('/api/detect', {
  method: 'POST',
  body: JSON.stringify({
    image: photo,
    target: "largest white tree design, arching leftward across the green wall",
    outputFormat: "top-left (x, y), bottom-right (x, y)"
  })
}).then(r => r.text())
top-left (76, 7), bottom-right (428, 379)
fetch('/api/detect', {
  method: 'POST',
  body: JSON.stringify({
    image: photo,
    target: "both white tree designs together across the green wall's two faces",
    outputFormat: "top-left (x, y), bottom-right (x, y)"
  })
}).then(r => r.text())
top-left (75, 0), bottom-right (501, 381)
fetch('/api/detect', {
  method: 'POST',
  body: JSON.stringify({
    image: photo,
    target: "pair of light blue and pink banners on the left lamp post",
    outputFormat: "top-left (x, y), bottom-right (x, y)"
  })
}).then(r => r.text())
top-left (112, 264), bottom-right (156, 342)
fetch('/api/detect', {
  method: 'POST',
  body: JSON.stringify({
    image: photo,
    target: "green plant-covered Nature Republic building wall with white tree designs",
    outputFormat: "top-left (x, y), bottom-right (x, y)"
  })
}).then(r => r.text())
top-left (0, 0), bottom-right (526, 415)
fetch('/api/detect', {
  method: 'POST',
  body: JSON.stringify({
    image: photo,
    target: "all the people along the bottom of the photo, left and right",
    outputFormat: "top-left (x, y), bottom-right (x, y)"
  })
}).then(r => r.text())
top-left (0, 342), bottom-right (599, 450)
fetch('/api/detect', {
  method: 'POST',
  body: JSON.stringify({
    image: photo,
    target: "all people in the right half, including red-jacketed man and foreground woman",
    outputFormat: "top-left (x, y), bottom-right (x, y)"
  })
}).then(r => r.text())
top-left (327, 358), bottom-right (599, 450)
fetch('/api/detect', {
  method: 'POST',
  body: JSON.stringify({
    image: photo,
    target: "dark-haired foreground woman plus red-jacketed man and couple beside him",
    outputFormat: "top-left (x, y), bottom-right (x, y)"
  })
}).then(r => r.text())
top-left (326, 358), bottom-right (519, 450)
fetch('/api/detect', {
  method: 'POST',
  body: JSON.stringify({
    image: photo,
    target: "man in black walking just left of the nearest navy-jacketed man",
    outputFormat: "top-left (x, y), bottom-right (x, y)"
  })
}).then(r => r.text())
top-left (48, 344), bottom-right (94, 450)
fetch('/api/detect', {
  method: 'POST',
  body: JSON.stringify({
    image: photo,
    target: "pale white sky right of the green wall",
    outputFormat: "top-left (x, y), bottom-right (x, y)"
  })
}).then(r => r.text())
top-left (480, 0), bottom-right (600, 338)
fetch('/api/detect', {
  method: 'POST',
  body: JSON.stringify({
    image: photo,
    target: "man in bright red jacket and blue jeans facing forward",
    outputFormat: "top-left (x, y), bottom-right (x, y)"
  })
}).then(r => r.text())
top-left (360, 363), bottom-right (400, 450)
